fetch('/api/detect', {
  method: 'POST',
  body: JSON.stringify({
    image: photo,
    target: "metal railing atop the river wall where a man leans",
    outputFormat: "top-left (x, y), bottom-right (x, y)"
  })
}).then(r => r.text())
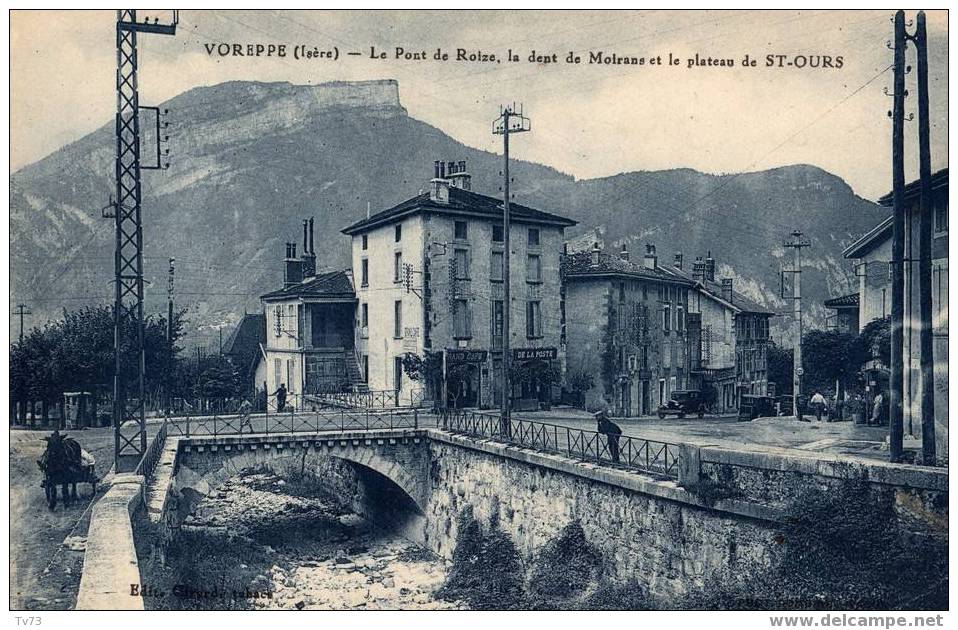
top-left (439, 409), bottom-right (679, 478)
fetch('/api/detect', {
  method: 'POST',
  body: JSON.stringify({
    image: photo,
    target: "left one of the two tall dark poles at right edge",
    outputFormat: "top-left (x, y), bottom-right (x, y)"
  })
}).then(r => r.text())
top-left (888, 11), bottom-right (906, 462)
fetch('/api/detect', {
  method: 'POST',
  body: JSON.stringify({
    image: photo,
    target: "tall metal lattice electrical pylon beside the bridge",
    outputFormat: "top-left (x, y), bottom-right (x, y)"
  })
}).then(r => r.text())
top-left (110, 9), bottom-right (179, 472)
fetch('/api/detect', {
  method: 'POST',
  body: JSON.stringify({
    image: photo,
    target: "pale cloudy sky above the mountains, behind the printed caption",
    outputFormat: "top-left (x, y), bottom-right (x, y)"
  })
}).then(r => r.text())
top-left (10, 10), bottom-right (948, 199)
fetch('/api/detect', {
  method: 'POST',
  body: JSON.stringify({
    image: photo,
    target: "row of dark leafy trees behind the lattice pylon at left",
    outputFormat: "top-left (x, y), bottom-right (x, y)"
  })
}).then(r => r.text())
top-left (10, 306), bottom-right (248, 428)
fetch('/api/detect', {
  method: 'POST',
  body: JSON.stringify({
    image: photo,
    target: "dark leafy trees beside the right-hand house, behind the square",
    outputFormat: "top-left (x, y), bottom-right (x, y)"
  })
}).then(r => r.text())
top-left (768, 318), bottom-right (891, 394)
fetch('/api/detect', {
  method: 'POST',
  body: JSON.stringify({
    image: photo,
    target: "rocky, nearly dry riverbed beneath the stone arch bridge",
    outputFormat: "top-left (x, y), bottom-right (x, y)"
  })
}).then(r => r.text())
top-left (153, 471), bottom-right (466, 610)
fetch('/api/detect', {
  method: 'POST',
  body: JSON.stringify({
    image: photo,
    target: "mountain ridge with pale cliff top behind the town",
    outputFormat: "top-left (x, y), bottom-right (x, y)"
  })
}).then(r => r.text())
top-left (10, 79), bottom-right (887, 346)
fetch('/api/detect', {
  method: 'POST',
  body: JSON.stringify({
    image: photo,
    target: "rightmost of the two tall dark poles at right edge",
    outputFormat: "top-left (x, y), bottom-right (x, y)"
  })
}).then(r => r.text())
top-left (912, 11), bottom-right (936, 466)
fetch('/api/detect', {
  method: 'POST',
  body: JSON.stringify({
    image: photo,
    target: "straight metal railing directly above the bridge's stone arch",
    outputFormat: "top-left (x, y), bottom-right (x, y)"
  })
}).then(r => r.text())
top-left (167, 409), bottom-right (426, 437)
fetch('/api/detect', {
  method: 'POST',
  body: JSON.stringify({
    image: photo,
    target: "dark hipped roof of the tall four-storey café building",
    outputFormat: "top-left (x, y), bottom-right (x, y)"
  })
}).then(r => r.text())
top-left (342, 186), bottom-right (576, 235)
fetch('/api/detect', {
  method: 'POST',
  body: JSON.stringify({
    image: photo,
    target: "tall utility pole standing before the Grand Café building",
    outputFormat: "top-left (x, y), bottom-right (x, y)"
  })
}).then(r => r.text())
top-left (492, 103), bottom-right (532, 437)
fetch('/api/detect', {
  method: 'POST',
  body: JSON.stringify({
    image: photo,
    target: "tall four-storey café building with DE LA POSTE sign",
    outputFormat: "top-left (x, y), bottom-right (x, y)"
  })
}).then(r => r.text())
top-left (343, 162), bottom-right (575, 408)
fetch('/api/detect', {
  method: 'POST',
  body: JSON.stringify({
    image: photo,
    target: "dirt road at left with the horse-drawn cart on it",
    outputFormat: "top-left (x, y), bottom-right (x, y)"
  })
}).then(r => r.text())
top-left (10, 428), bottom-right (113, 610)
